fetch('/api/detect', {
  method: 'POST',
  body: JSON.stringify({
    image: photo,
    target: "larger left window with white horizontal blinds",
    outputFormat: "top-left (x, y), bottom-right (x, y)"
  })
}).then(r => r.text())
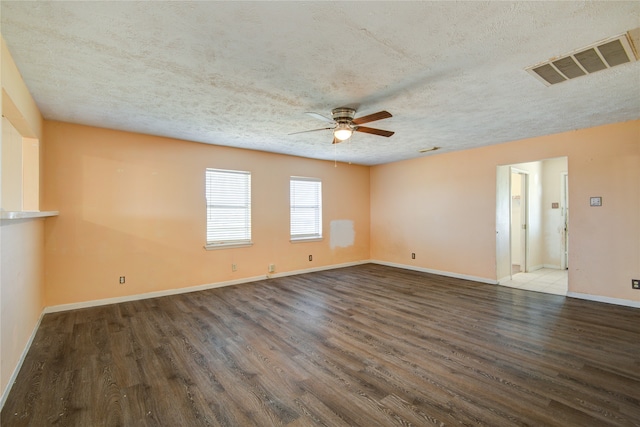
top-left (205, 169), bottom-right (251, 249)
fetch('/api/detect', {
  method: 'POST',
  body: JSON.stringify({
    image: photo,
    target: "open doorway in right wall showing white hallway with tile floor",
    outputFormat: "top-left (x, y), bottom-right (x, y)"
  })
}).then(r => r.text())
top-left (496, 157), bottom-right (569, 295)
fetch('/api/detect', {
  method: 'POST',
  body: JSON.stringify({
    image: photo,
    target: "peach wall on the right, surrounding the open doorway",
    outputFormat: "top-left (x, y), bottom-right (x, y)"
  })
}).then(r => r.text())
top-left (371, 121), bottom-right (640, 302)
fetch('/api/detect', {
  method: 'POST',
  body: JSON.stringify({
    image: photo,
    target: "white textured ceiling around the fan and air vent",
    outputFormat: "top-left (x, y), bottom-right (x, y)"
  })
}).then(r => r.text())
top-left (0, 0), bottom-right (640, 165)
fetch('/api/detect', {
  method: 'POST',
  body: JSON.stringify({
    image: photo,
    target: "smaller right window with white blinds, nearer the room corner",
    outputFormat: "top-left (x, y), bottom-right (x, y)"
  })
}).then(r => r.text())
top-left (289, 177), bottom-right (322, 240)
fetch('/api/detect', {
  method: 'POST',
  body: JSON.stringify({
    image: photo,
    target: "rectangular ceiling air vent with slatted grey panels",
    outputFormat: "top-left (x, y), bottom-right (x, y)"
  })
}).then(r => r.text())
top-left (526, 28), bottom-right (640, 86)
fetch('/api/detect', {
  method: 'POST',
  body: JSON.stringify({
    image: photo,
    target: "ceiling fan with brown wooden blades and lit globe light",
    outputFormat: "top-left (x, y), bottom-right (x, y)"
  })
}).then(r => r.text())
top-left (289, 107), bottom-right (394, 144)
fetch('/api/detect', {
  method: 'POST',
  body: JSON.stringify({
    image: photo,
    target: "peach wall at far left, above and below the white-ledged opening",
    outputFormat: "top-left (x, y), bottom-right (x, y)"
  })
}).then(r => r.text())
top-left (0, 37), bottom-right (46, 406)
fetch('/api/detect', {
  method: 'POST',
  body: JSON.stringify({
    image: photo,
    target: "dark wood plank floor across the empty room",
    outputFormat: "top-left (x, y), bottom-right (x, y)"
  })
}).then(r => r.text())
top-left (1, 265), bottom-right (640, 427)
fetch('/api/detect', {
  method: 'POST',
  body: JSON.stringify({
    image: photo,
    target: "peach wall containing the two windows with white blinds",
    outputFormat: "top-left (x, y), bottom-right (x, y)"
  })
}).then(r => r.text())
top-left (43, 121), bottom-right (370, 306)
